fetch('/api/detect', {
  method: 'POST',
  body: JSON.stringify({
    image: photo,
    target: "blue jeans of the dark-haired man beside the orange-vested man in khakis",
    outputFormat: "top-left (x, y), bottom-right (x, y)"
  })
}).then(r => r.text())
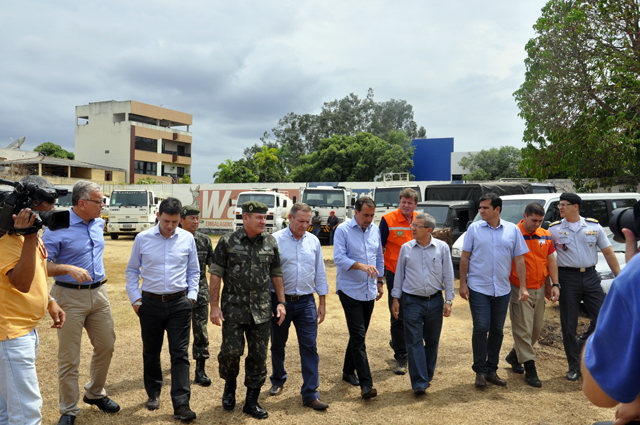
top-left (469, 288), bottom-right (511, 373)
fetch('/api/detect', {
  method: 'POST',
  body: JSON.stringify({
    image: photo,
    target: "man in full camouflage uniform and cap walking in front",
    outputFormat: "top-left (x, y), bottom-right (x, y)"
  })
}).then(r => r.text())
top-left (209, 201), bottom-right (286, 419)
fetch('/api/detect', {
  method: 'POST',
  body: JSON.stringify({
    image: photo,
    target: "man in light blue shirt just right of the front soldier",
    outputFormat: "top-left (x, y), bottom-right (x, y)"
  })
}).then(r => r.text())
top-left (269, 203), bottom-right (329, 410)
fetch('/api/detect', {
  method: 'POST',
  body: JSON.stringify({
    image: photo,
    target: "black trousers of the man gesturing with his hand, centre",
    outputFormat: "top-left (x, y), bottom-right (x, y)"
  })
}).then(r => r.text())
top-left (338, 291), bottom-right (375, 387)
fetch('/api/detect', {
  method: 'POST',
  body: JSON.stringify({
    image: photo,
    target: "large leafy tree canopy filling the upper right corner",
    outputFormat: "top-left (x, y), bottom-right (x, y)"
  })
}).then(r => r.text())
top-left (514, 0), bottom-right (640, 189)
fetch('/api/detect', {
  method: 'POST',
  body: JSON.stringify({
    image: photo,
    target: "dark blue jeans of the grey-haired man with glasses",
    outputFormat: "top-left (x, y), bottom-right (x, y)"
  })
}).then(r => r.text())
top-left (402, 293), bottom-right (444, 390)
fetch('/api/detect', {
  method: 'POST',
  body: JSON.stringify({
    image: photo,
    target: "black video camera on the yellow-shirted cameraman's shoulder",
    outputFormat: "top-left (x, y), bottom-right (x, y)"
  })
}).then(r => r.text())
top-left (0, 179), bottom-right (69, 237)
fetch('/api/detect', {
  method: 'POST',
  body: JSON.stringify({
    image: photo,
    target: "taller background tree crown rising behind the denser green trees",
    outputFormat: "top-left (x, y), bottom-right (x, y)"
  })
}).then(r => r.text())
top-left (244, 89), bottom-right (426, 170)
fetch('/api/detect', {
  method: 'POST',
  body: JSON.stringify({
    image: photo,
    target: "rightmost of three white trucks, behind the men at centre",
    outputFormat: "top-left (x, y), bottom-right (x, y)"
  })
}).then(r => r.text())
top-left (293, 186), bottom-right (356, 240)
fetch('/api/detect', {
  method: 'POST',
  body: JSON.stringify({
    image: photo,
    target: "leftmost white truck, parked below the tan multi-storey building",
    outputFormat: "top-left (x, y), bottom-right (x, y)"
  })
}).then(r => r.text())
top-left (107, 189), bottom-right (163, 239)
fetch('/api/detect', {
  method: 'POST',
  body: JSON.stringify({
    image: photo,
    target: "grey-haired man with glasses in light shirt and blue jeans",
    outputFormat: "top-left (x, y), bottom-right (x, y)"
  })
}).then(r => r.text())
top-left (391, 213), bottom-right (454, 395)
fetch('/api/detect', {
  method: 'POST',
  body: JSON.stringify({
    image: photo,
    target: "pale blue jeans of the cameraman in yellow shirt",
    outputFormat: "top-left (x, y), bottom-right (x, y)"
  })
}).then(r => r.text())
top-left (0, 329), bottom-right (42, 425)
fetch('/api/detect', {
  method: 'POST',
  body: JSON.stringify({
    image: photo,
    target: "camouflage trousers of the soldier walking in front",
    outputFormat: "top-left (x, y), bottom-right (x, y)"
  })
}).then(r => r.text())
top-left (218, 321), bottom-right (271, 388)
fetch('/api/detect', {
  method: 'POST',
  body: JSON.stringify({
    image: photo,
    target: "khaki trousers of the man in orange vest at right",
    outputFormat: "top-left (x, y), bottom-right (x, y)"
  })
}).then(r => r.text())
top-left (509, 285), bottom-right (544, 363)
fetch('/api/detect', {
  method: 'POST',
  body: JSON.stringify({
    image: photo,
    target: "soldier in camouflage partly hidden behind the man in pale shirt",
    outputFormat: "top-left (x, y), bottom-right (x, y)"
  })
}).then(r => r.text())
top-left (180, 205), bottom-right (213, 387)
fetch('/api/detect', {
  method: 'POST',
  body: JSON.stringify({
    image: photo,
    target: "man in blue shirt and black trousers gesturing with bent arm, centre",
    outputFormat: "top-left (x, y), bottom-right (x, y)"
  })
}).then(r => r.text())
top-left (333, 196), bottom-right (384, 400)
